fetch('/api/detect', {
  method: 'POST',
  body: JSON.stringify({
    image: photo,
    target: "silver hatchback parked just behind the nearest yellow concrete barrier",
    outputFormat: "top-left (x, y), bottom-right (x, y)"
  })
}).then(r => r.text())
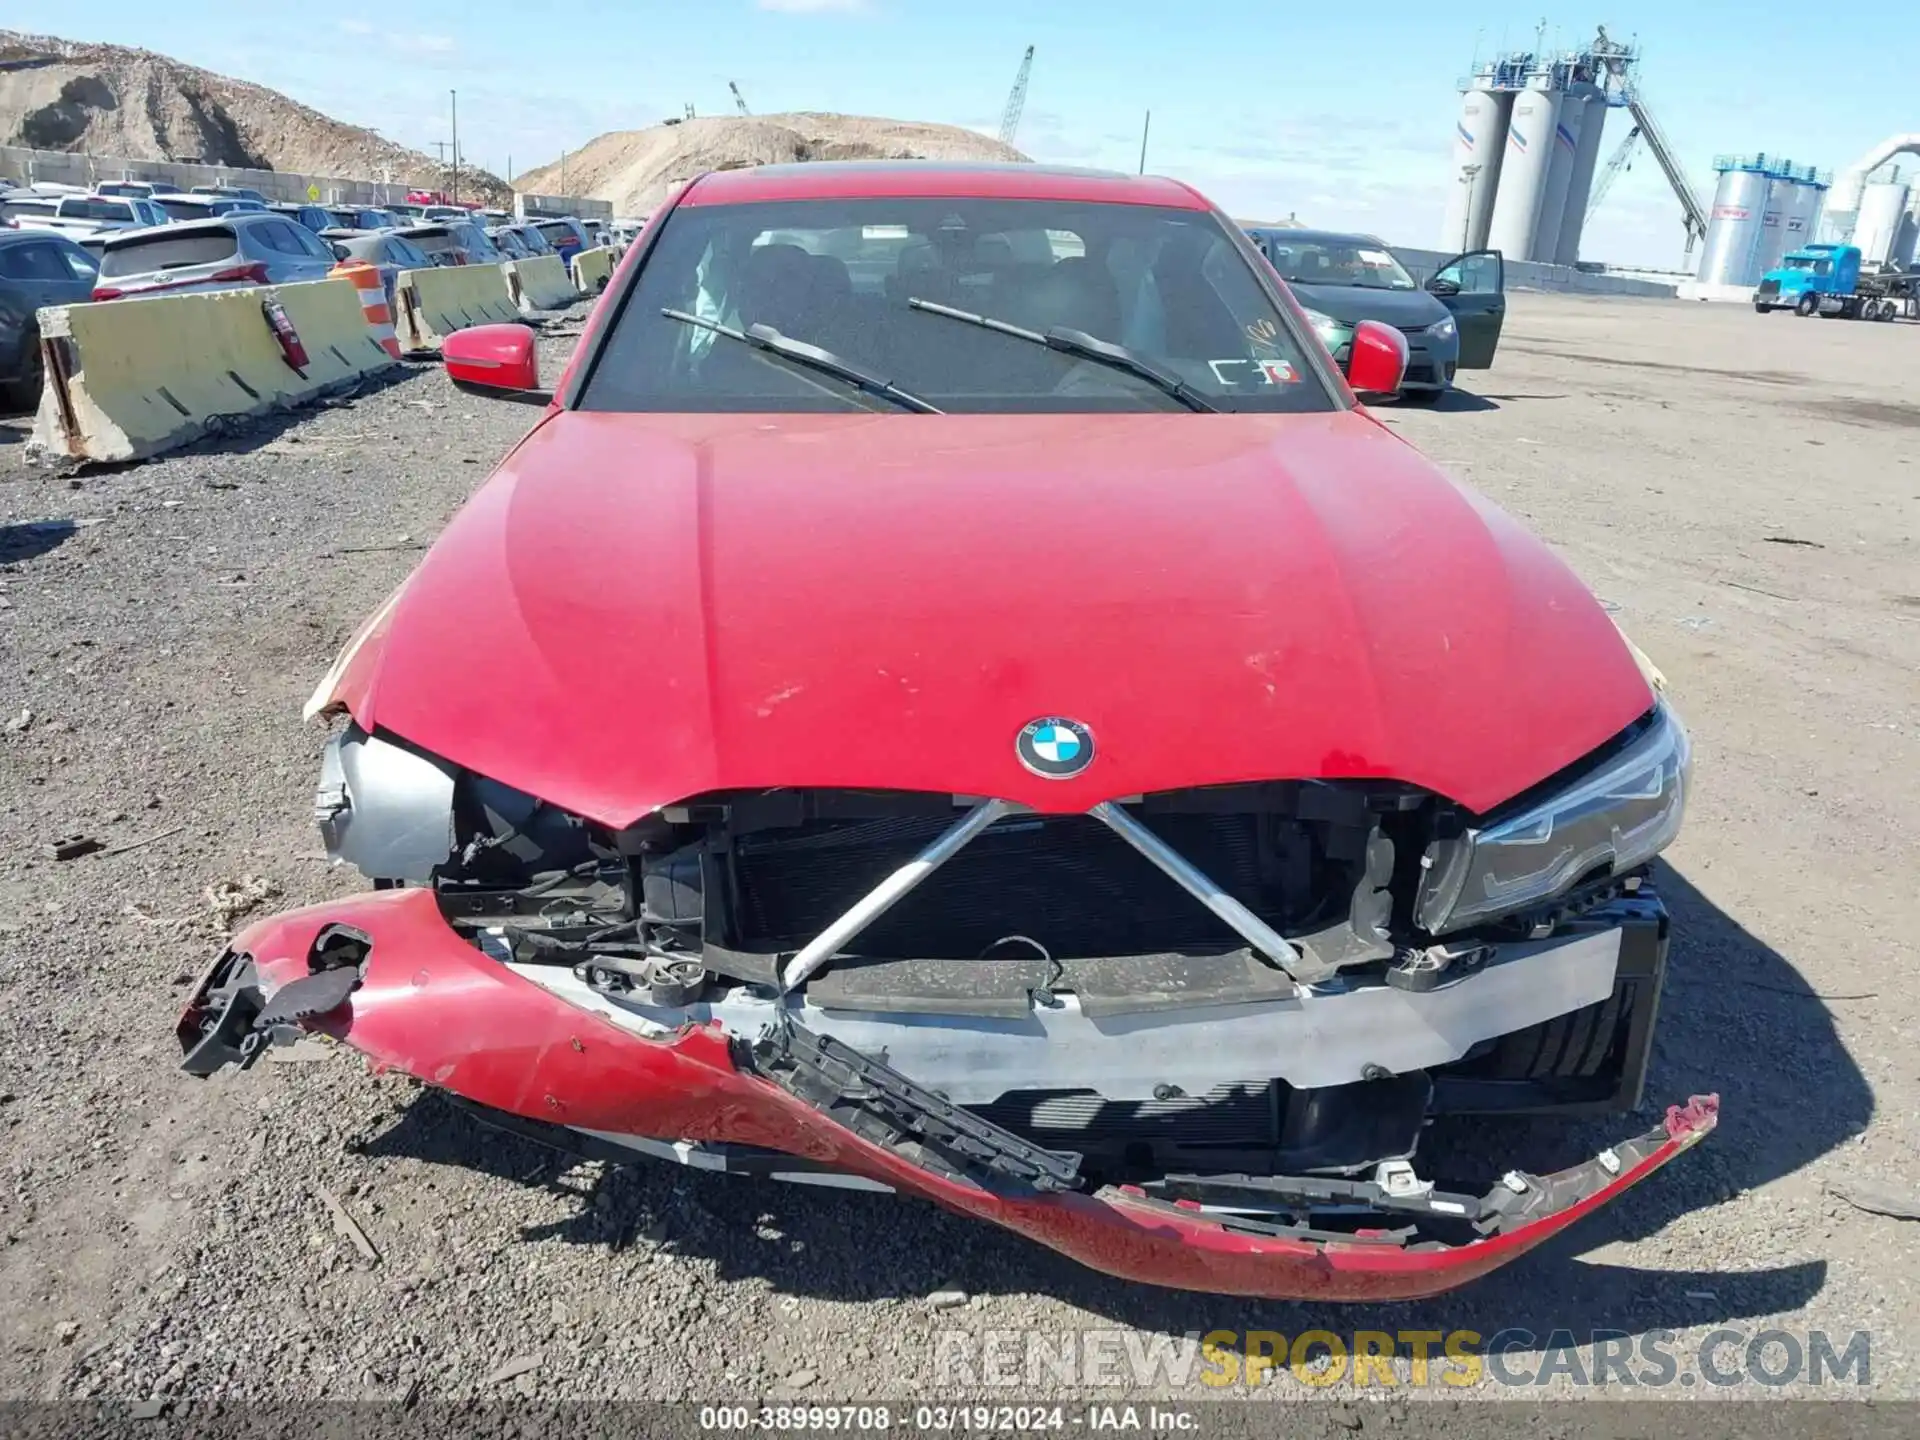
top-left (94, 209), bottom-right (334, 300)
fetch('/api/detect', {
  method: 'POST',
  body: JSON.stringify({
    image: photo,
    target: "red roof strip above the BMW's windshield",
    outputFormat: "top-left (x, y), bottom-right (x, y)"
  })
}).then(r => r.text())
top-left (680, 159), bottom-right (1210, 209)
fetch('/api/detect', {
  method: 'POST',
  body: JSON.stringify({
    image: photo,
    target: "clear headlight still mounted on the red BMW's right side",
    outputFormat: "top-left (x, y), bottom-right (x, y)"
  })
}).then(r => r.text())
top-left (1413, 701), bottom-right (1693, 935)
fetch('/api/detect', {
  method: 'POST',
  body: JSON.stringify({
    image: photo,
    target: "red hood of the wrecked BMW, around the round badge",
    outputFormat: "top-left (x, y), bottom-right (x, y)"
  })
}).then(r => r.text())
top-left (332, 411), bottom-right (1651, 826)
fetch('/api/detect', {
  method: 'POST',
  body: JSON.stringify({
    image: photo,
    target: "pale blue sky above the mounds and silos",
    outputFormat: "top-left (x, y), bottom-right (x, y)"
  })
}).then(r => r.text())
top-left (8, 0), bottom-right (1920, 265)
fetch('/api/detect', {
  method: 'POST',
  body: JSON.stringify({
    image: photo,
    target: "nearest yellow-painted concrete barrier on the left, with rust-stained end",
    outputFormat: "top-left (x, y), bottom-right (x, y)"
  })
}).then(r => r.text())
top-left (29, 280), bottom-right (394, 461)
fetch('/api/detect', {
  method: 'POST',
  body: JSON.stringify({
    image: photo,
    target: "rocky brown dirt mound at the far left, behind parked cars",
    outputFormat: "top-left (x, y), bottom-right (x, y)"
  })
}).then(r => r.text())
top-left (0, 31), bottom-right (513, 204)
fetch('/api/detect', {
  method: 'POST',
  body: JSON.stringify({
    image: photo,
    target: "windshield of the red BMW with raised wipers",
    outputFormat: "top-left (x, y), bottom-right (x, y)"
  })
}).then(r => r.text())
top-left (580, 198), bottom-right (1334, 413)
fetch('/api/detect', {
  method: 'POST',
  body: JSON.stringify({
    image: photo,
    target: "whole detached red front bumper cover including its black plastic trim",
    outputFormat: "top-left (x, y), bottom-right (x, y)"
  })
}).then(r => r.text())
top-left (180, 889), bottom-right (1716, 1300)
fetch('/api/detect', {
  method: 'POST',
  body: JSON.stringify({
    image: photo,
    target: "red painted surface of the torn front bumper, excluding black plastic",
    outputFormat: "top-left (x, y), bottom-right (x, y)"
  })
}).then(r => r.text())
top-left (196, 889), bottom-right (1715, 1300)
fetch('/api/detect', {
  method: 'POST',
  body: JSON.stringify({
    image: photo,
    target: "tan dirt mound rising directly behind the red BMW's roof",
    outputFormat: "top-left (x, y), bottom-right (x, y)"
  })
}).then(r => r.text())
top-left (515, 111), bottom-right (1027, 215)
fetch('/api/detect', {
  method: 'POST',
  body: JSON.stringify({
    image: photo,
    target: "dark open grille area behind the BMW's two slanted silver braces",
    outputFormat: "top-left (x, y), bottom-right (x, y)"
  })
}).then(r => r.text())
top-left (730, 812), bottom-right (1352, 960)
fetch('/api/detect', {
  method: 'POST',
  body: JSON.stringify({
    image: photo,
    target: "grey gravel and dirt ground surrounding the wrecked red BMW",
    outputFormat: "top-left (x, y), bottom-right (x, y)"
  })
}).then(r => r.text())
top-left (0, 296), bottom-right (1920, 1432)
